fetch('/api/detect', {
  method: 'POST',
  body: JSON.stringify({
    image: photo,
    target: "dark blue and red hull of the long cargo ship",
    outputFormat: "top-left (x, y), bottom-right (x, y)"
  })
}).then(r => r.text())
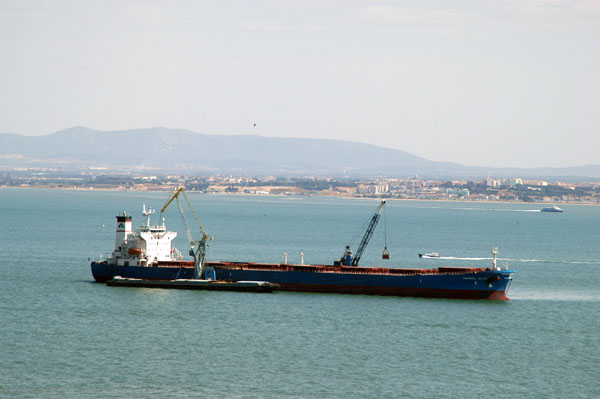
top-left (91, 262), bottom-right (514, 300)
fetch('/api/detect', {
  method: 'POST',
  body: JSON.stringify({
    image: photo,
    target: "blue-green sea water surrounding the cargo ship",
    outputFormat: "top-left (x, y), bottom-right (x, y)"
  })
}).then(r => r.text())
top-left (0, 188), bottom-right (600, 398)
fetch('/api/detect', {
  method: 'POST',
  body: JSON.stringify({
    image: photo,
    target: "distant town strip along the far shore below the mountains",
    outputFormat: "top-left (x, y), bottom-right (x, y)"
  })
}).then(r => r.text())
top-left (0, 169), bottom-right (600, 204)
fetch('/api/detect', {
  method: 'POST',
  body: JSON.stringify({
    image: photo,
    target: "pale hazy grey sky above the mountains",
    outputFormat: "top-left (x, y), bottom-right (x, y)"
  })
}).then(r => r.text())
top-left (0, 0), bottom-right (600, 167)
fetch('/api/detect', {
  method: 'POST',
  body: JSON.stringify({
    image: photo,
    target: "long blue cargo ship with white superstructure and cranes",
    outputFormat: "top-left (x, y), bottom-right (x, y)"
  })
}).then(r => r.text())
top-left (91, 191), bottom-right (514, 300)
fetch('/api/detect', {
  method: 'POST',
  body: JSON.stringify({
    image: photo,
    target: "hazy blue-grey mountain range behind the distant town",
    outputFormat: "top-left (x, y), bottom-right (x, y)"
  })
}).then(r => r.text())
top-left (0, 126), bottom-right (600, 179)
